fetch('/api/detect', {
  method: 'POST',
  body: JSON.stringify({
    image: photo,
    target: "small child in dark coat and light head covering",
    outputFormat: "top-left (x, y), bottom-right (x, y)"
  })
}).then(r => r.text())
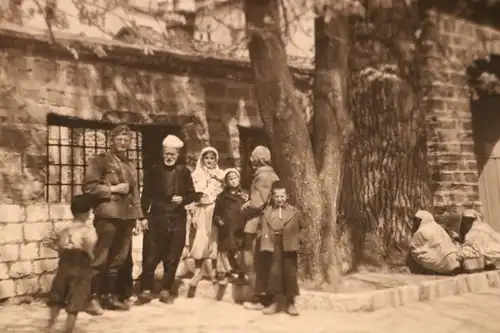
top-left (213, 169), bottom-right (248, 285)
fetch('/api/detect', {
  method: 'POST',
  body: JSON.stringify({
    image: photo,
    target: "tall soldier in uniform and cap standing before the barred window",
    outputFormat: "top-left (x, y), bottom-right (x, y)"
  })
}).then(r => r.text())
top-left (82, 125), bottom-right (143, 315)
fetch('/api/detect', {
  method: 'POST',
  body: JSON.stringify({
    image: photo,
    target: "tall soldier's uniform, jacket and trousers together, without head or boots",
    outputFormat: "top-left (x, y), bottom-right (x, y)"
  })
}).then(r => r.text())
top-left (82, 152), bottom-right (143, 295)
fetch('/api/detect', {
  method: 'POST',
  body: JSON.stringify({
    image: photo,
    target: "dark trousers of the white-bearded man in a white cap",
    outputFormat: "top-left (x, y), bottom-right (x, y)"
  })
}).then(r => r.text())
top-left (141, 215), bottom-right (186, 291)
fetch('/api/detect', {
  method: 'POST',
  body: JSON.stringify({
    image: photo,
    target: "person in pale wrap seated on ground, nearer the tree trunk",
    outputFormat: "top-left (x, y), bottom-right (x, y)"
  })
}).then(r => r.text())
top-left (410, 210), bottom-right (461, 275)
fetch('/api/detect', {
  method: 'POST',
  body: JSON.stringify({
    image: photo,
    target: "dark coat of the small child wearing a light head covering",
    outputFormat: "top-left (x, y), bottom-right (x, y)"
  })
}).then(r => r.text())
top-left (213, 189), bottom-right (248, 251)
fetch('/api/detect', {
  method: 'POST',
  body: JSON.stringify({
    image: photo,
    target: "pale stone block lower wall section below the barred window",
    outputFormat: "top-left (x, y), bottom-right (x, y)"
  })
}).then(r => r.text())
top-left (0, 204), bottom-right (71, 299)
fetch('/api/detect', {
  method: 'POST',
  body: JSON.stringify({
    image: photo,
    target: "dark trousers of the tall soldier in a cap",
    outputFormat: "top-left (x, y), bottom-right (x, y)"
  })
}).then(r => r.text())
top-left (92, 218), bottom-right (135, 296)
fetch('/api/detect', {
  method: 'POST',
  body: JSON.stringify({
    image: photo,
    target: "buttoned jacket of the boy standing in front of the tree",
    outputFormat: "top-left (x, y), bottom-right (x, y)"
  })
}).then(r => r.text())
top-left (260, 204), bottom-right (306, 252)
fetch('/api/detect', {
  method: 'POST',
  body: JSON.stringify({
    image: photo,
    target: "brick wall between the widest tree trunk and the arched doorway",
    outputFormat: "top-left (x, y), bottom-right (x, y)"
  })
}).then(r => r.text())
top-left (428, 13), bottom-right (500, 215)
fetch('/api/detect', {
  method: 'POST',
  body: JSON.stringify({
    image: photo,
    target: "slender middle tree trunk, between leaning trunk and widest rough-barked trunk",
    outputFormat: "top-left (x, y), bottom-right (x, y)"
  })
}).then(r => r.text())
top-left (313, 12), bottom-right (352, 286)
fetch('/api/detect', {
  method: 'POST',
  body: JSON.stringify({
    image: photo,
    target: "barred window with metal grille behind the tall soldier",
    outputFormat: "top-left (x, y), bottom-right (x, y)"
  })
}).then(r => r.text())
top-left (45, 115), bottom-right (143, 203)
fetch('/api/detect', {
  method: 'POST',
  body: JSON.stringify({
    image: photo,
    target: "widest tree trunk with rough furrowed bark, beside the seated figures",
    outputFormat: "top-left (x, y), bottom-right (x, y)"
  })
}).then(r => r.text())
top-left (341, 63), bottom-right (429, 270)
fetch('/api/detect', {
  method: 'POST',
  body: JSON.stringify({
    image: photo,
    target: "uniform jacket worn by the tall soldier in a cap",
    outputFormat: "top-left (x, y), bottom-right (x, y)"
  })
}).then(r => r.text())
top-left (82, 152), bottom-right (143, 220)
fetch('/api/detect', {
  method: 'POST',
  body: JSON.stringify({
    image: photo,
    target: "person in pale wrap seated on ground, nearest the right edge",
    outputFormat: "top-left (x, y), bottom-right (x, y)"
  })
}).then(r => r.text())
top-left (458, 209), bottom-right (500, 273)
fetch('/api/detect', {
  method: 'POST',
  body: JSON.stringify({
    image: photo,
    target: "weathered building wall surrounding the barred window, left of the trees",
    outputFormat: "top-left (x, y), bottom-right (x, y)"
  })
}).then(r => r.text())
top-left (0, 27), bottom-right (306, 299)
